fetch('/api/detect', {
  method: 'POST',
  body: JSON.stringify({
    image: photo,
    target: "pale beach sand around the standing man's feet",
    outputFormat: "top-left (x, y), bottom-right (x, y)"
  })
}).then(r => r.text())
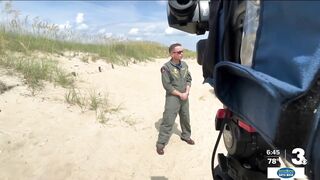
top-left (0, 57), bottom-right (223, 180)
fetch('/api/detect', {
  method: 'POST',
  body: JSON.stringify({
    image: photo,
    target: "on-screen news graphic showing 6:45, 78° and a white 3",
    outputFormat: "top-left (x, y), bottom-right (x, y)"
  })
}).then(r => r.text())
top-left (266, 148), bottom-right (307, 180)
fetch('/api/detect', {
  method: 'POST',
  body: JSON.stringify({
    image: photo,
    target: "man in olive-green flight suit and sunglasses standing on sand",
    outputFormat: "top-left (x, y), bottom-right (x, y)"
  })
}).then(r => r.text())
top-left (156, 43), bottom-right (194, 155)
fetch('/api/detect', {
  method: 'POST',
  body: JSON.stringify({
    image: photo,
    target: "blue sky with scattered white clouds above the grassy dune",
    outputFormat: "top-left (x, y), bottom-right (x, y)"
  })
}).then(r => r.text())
top-left (1, 0), bottom-right (207, 50)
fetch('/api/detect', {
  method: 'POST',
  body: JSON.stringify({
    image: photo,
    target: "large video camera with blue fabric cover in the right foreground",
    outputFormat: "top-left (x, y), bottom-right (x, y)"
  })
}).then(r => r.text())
top-left (167, 0), bottom-right (320, 180)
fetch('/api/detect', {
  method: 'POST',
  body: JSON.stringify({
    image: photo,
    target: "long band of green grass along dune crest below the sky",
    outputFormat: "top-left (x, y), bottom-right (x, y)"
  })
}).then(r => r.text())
top-left (0, 28), bottom-right (195, 62)
